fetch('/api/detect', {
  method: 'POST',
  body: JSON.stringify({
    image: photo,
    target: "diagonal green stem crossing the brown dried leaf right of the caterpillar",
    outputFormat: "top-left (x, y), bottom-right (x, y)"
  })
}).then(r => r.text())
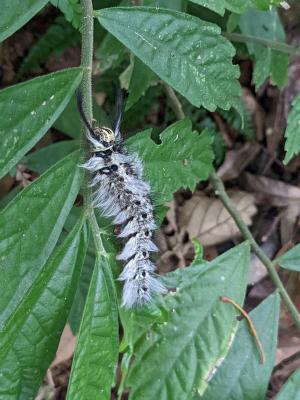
top-left (210, 172), bottom-right (300, 331)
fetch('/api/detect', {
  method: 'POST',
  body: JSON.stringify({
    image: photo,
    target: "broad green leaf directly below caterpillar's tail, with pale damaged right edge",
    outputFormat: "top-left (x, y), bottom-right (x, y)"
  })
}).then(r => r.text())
top-left (126, 243), bottom-right (249, 400)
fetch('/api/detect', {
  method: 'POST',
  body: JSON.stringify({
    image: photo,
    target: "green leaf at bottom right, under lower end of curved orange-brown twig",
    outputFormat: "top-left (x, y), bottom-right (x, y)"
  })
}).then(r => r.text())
top-left (201, 293), bottom-right (280, 400)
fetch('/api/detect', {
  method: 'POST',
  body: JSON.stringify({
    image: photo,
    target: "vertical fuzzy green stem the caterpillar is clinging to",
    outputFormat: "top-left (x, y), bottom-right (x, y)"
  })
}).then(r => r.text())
top-left (81, 0), bottom-right (106, 256)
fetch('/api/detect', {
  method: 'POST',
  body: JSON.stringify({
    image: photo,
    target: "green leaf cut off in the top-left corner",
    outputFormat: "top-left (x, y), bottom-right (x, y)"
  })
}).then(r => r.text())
top-left (0, 0), bottom-right (48, 42)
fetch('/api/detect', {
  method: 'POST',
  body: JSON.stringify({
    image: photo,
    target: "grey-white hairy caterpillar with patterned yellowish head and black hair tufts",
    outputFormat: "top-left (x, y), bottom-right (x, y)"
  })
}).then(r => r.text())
top-left (77, 92), bottom-right (165, 308)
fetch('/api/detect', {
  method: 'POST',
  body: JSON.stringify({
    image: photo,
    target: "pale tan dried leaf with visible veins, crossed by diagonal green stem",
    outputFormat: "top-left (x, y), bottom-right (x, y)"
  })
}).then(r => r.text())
top-left (178, 191), bottom-right (256, 246)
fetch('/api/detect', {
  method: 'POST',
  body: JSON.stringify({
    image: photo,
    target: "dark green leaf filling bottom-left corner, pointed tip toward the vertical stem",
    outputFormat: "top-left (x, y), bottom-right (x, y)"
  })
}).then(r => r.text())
top-left (0, 214), bottom-right (87, 400)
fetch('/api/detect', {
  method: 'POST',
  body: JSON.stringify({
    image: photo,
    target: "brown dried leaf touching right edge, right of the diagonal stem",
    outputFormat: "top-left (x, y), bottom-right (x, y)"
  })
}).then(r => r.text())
top-left (244, 173), bottom-right (300, 207)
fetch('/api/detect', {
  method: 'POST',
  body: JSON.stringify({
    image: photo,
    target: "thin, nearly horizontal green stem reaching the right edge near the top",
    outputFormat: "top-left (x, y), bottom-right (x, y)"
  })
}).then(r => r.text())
top-left (222, 32), bottom-right (300, 54)
